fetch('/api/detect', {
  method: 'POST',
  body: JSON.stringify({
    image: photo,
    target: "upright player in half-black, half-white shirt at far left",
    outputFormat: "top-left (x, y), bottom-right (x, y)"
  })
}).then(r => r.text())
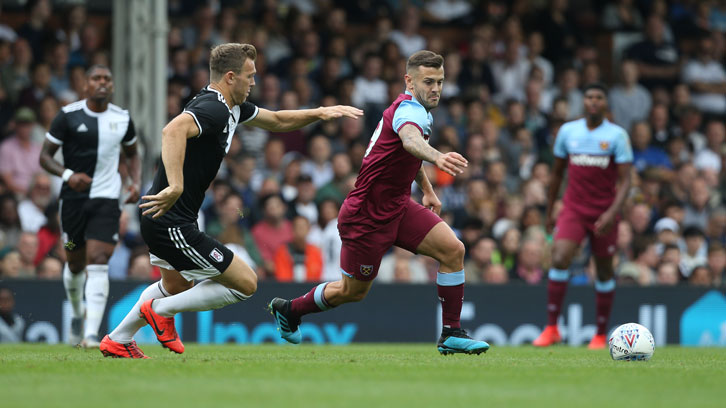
top-left (40, 65), bottom-right (141, 347)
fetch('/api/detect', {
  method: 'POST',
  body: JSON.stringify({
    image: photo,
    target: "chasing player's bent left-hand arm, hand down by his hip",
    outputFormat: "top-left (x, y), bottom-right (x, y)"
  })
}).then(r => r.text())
top-left (139, 112), bottom-right (201, 218)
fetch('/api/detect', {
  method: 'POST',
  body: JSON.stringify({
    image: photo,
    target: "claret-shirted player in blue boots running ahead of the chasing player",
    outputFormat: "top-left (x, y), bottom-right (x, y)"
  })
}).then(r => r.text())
top-left (268, 51), bottom-right (489, 354)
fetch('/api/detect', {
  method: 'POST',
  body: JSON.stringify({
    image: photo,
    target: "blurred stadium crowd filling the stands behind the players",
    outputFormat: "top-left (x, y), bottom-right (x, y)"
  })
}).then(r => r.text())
top-left (0, 0), bottom-right (726, 286)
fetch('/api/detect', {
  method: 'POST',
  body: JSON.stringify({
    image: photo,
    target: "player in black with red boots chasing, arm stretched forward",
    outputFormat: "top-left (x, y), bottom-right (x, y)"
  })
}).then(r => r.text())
top-left (101, 43), bottom-right (363, 358)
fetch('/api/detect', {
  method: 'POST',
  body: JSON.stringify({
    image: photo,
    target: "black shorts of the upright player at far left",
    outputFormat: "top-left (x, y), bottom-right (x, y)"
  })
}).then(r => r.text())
top-left (59, 198), bottom-right (121, 251)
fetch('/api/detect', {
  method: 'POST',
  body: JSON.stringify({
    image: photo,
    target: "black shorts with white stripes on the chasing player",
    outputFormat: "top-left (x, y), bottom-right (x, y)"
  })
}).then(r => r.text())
top-left (141, 216), bottom-right (234, 280)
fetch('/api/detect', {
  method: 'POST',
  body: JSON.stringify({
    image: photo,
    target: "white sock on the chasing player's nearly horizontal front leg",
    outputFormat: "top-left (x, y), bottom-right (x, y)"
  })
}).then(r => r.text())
top-left (152, 279), bottom-right (249, 318)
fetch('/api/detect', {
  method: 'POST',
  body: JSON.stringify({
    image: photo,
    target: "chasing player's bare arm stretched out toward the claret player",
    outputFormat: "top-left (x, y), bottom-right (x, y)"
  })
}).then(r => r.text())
top-left (247, 105), bottom-right (363, 132)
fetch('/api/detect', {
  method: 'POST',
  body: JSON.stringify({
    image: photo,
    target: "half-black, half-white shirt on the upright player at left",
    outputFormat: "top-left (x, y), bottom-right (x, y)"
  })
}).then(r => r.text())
top-left (45, 99), bottom-right (136, 199)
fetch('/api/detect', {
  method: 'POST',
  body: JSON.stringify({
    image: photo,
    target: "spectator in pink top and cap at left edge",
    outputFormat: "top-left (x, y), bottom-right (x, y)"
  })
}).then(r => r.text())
top-left (0, 108), bottom-right (41, 196)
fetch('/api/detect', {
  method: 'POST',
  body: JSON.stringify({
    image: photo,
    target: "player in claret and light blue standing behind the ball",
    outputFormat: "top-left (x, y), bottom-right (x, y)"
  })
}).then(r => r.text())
top-left (532, 83), bottom-right (633, 349)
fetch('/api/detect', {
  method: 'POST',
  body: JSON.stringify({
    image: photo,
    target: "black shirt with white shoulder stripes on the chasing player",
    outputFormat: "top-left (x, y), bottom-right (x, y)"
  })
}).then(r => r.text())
top-left (147, 86), bottom-right (259, 226)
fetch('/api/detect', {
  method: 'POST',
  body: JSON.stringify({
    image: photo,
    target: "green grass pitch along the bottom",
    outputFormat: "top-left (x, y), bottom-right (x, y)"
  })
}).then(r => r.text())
top-left (0, 344), bottom-right (726, 408)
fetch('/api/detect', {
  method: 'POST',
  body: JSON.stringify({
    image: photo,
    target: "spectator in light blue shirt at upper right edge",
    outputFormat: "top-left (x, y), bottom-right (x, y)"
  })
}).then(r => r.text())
top-left (682, 36), bottom-right (726, 115)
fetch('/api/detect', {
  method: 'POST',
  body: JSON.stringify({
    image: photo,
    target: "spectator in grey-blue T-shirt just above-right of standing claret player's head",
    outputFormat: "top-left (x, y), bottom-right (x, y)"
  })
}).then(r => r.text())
top-left (608, 60), bottom-right (653, 129)
